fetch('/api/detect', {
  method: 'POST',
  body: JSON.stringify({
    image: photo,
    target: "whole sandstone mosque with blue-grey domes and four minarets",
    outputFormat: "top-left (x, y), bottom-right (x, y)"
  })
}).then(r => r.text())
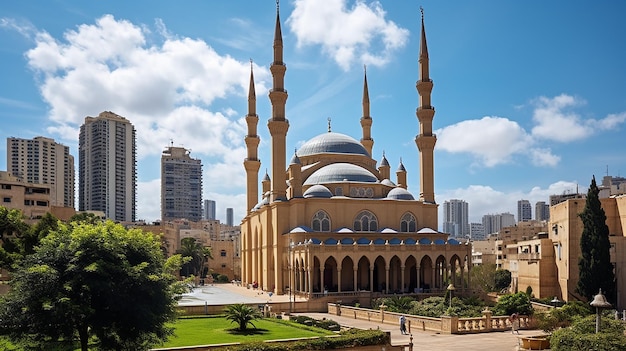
top-left (241, 7), bottom-right (471, 298)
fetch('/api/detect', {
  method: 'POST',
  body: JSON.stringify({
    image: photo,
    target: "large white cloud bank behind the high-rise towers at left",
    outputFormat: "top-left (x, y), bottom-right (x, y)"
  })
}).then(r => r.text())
top-left (17, 15), bottom-right (270, 224)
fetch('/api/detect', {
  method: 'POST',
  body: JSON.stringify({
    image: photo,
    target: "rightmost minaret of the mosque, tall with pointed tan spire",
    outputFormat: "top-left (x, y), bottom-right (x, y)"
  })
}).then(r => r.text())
top-left (415, 8), bottom-right (437, 203)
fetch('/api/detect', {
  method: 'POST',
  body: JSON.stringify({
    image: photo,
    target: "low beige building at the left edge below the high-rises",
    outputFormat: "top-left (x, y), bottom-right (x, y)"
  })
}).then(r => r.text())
top-left (0, 171), bottom-right (50, 220)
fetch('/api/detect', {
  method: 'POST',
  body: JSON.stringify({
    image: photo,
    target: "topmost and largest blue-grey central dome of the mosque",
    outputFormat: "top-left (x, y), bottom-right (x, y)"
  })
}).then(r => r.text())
top-left (298, 132), bottom-right (370, 157)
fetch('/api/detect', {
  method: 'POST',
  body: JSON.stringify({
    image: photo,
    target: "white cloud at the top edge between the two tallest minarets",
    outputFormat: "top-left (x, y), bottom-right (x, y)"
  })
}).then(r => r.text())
top-left (287, 0), bottom-right (409, 70)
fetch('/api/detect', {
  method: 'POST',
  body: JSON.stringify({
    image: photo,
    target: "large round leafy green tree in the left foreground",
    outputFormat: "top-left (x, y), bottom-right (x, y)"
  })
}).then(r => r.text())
top-left (0, 221), bottom-right (180, 351)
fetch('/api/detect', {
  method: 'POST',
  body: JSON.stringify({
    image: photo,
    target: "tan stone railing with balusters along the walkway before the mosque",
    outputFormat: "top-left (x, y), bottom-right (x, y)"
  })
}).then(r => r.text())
top-left (328, 303), bottom-right (533, 334)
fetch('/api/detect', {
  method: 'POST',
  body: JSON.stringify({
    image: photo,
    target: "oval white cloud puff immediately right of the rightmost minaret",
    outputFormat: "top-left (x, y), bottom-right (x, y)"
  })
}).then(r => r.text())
top-left (436, 117), bottom-right (532, 167)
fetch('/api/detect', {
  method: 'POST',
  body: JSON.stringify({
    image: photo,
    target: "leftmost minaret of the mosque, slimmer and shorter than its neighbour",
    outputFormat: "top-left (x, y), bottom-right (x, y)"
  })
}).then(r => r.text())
top-left (243, 60), bottom-right (261, 211)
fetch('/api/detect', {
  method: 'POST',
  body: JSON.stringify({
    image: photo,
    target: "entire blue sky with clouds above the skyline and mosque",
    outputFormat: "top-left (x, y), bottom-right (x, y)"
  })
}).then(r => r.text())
top-left (0, 0), bottom-right (626, 227)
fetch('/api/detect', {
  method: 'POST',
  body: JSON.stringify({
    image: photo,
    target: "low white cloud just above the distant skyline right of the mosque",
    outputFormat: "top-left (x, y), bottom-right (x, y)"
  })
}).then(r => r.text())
top-left (437, 181), bottom-right (584, 223)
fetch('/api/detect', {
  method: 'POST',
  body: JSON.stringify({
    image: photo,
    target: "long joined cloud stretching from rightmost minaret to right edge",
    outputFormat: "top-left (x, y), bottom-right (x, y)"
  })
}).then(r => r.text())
top-left (436, 94), bottom-right (626, 167)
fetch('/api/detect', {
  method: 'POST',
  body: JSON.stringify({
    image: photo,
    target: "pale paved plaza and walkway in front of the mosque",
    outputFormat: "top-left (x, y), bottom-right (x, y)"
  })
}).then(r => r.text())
top-left (180, 284), bottom-right (543, 351)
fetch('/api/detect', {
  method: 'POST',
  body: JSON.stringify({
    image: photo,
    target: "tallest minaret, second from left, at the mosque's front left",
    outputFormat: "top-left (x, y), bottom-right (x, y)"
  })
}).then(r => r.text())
top-left (267, 0), bottom-right (289, 202)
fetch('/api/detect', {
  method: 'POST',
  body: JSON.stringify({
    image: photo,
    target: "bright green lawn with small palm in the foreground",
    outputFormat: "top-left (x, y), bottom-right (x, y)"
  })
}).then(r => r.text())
top-left (156, 317), bottom-right (334, 347)
